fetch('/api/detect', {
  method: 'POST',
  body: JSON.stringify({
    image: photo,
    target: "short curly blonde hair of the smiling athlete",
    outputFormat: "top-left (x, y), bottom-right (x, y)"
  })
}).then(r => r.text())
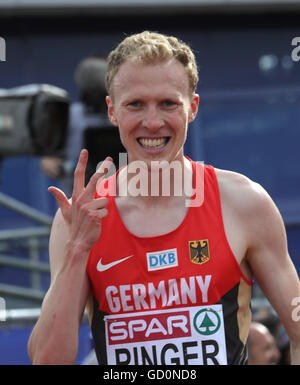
top-left (106, 31), bottom-right (198, 94)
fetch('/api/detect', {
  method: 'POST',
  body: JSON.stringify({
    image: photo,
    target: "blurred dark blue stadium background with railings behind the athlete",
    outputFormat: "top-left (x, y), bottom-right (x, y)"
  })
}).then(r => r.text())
top-left (0, 0), bottom-right (300, 364)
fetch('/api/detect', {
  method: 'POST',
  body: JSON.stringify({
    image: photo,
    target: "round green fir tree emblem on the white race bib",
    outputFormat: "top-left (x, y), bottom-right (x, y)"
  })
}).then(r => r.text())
top-left (194, 308), bottom-right (221, 336)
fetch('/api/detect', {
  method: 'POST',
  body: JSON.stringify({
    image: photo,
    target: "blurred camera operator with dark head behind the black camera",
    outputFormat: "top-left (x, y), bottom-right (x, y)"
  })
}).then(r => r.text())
top-left (41, 56), bottom-right (113, 197)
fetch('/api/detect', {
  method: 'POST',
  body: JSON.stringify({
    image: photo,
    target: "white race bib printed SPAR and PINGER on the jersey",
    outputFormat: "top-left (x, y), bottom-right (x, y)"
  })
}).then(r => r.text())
top-left (104, 304), bottom-right (227, 365)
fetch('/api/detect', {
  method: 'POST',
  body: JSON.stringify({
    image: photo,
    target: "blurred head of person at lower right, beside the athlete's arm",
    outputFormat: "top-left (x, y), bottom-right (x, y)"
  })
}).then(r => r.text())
top-left (248, 322), bottom-right (280, 365)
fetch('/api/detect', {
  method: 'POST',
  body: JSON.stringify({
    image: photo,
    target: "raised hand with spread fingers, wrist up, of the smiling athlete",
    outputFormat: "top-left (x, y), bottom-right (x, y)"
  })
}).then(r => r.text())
top-left (48, 150), bottom-right (113, 251)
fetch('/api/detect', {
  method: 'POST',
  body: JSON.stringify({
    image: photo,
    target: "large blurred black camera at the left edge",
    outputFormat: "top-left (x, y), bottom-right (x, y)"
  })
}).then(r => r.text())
top-left (0, 84), bottom-right (69, 158)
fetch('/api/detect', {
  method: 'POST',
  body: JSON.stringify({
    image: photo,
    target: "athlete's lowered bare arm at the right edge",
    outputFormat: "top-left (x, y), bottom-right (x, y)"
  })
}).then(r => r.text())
top-left (244, 182), bottom-right (300, 365)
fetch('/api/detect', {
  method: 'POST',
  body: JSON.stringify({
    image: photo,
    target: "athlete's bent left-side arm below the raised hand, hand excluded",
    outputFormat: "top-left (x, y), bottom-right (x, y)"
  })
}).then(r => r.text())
top-left (28, 211), bottom-right (89, 364)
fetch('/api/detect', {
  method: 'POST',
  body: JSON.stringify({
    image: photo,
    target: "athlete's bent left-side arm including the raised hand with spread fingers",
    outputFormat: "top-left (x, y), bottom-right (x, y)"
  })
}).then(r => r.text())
top-left (28, 150), bottom-right (111, 364)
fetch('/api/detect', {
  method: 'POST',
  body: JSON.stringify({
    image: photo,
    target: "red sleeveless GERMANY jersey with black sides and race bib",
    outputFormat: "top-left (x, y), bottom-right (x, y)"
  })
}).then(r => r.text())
top-left (87, 158), bottom-right (252, 365)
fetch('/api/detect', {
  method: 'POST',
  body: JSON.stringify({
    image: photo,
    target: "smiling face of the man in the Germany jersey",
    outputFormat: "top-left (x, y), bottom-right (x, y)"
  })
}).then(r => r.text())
top-left (107, 59), bottom-right (199, 164)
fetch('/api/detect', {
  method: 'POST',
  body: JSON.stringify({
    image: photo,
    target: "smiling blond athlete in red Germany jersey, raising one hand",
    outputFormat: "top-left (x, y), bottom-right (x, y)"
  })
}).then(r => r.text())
top-left (29, 31), bottom-right (300, 365)
